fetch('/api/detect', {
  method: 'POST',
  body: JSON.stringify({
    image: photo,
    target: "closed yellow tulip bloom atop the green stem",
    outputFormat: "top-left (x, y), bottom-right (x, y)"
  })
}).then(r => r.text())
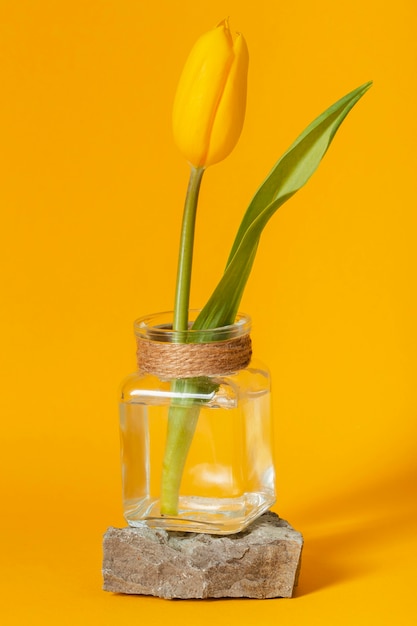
top-left (173, 20), bottom-right (249, 168)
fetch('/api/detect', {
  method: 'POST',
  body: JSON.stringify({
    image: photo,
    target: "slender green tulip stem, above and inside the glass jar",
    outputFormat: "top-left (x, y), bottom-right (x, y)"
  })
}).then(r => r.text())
top-left (161, 167), bottom-right (204, 515)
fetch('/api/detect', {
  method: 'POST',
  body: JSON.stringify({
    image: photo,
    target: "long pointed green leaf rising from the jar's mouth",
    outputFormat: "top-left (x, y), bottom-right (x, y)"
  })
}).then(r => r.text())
top-left (193, 82), bottom-right (372, 329)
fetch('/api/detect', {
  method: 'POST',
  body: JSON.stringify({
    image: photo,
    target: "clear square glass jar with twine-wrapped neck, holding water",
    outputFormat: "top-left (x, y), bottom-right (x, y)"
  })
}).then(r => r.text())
top-left (120, 312), bottom-right (275, 534)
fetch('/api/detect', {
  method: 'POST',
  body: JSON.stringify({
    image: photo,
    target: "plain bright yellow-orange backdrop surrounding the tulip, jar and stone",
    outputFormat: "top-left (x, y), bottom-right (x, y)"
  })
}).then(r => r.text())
top-left (0, 0), bottom-right (417, 626)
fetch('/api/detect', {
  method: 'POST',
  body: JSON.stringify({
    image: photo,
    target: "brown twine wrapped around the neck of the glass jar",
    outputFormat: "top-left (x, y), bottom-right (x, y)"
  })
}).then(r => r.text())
top-left (136, 334), bottom-right (252, 379)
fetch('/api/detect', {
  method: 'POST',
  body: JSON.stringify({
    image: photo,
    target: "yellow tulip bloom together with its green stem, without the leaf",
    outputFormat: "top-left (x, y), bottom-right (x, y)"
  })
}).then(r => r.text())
top-left (161, 20), bottom-right (249, 515)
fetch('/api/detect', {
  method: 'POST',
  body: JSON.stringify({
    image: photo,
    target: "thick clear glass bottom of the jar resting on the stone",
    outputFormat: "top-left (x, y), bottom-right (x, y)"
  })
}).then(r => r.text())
top-left (125, 493), bottom-right (275, 535)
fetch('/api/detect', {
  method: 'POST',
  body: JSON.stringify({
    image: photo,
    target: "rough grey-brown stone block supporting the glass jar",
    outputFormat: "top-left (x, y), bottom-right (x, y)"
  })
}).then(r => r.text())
top-left (103, 511), bottom-right (303, 599)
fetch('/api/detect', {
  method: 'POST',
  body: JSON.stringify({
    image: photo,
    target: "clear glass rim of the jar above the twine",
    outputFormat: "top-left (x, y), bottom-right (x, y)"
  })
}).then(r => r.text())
top-left (134, 309), bottom-right (252, 343)
